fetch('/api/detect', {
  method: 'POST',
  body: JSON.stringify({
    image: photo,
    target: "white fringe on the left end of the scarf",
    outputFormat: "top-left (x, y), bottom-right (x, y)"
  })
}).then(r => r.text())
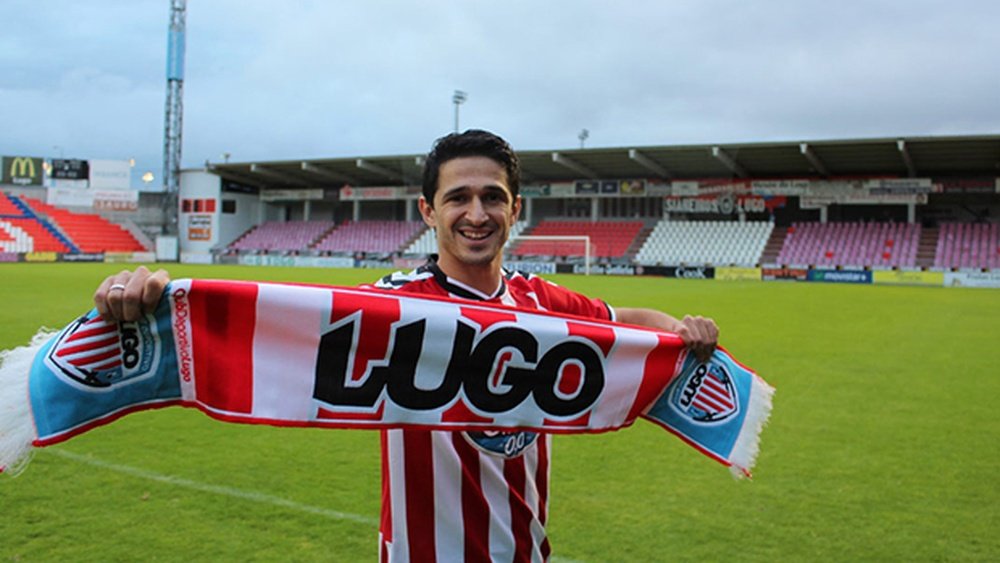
top-left (0, 328), bottom-right (55, 476)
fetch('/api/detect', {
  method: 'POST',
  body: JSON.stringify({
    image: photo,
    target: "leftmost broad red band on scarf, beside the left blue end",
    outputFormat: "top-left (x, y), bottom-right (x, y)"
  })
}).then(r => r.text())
top-left (188, 280), bottom-right (257, 414)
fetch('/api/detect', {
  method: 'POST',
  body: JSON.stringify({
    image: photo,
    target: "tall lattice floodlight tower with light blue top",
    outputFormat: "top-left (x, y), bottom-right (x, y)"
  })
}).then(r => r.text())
top-left (163, 0), bottom-right (187, 235)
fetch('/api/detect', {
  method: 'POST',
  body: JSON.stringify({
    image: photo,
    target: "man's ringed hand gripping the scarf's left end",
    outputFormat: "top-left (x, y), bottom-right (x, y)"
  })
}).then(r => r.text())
top-left (94, 266), bottom-right (170, 322)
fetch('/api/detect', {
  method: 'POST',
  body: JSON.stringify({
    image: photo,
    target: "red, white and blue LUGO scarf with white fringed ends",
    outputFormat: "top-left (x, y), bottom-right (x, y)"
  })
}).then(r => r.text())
top-left (0, 280), bottom-right (774, 476)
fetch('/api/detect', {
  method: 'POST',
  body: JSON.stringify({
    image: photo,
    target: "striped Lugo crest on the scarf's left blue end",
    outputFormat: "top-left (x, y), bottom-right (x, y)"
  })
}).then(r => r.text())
top-left (45, 316), bottom-right (159, 390)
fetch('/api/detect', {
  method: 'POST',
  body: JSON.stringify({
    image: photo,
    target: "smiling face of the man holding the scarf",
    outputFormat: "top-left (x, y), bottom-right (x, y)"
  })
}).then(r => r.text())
top-left (420, 156), bottom-right (521, 268)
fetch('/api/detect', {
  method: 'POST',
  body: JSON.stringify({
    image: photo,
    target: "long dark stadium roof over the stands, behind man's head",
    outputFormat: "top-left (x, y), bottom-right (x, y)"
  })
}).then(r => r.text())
top-left (208, 135), bottom-right (1000, 189)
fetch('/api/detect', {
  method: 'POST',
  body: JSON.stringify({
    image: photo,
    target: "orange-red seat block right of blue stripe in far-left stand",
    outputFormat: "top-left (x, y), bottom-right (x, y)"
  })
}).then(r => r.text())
top-left (23, 197), bottom-right (147, 252)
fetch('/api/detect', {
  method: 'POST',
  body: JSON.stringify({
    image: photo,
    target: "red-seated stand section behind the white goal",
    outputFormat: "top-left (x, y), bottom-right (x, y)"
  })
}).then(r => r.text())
top-left (511, 219), bottom-right (643, 258)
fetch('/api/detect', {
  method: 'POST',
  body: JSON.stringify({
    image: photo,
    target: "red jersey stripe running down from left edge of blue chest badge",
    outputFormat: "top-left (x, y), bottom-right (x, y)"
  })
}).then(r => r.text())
top-left (451, 432), bottom-right (490, 561)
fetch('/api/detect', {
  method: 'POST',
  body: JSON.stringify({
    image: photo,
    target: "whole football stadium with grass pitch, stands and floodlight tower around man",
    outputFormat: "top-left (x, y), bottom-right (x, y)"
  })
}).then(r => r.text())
top-left (0, 0), bottom-right (1000, 563)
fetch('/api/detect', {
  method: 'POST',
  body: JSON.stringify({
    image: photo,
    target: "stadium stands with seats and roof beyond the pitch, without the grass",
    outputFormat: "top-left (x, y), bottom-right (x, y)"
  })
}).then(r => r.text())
top-left (0, 136), bottom-right (1000, 287)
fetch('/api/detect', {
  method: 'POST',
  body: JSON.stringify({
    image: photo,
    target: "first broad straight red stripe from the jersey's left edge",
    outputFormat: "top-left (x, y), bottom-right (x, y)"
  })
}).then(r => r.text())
top-left (403, 430), bottom-right (437, 561)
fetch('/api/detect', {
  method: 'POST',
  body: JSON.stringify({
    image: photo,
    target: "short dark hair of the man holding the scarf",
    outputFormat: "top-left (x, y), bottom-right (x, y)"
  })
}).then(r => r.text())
top-left (423, 129), bottom-right (521, 206)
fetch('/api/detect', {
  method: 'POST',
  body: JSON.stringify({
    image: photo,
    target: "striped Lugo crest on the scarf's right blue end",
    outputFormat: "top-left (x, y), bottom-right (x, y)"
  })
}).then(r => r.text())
top-left (670, 362), bottom-right (739, 423)
